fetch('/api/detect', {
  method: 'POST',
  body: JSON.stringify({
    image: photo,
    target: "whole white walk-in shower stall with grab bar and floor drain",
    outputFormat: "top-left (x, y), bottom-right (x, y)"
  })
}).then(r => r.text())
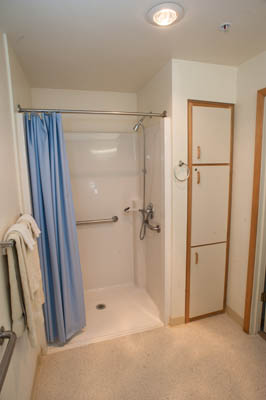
top-left (15, 107), bottom-right (171, 351)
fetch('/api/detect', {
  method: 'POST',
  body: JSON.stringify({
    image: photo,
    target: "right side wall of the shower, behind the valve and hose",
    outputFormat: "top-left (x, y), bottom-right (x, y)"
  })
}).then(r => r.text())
top-left (137, 118), bottom-right (171, 323)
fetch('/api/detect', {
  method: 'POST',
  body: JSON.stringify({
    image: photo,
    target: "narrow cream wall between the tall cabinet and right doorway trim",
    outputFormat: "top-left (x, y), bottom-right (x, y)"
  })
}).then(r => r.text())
top-left (227, 52), bottom-right (266, 317)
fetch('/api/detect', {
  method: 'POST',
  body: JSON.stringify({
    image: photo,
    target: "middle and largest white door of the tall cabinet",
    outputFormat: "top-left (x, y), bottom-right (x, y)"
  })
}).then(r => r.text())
top-left (191, 165), bottom-right (230, 246)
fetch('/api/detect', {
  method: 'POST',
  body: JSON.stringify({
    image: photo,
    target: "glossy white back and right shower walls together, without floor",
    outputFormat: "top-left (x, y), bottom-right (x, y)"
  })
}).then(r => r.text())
top-left (65, 120), bottom-right (166, 319)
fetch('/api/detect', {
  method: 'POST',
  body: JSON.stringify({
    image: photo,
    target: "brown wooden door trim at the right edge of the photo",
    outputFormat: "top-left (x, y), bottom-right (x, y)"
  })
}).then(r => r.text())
top-left (243, 88), bottom-right (266, 333)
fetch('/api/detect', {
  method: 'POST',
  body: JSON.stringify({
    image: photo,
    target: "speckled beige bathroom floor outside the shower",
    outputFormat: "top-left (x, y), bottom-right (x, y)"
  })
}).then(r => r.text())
top-left (34, 315), bottom-right (266, 400)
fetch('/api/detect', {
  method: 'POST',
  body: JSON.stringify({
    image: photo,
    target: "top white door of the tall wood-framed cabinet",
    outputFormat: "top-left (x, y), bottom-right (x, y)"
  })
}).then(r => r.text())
top-left (192, 106), bottom-right (231, 164)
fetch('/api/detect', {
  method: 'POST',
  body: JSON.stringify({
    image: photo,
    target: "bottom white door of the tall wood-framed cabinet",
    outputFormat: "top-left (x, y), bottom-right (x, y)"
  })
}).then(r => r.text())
top-left (189, 243), bottom-right (226, 318)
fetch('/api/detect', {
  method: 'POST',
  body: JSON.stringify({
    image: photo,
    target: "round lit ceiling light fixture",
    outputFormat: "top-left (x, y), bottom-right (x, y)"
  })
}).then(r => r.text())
top-left (147, 3), bottom-right (184, 26)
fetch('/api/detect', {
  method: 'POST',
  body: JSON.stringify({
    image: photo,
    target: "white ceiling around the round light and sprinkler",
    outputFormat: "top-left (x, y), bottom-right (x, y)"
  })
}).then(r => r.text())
top-left (0, 0), bottom-right (266, 92)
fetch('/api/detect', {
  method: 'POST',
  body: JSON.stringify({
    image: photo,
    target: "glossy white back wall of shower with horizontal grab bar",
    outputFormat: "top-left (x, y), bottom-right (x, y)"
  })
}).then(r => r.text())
top-left (65, 132), bottom-right (139, 290)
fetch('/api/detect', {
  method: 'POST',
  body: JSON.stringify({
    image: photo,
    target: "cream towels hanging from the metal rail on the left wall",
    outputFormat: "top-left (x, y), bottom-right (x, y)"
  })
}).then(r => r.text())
top-left (5, 223), bottom-right (44, 347)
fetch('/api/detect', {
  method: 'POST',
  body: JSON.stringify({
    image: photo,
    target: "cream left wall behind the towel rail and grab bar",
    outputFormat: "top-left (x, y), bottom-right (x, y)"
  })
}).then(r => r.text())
top-left (0, 34), bottom-right (39, 400)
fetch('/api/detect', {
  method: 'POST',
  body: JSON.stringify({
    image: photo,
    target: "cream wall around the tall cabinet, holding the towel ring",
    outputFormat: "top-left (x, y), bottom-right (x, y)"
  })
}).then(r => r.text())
top-left (138, 60), bottom-right (237, 321)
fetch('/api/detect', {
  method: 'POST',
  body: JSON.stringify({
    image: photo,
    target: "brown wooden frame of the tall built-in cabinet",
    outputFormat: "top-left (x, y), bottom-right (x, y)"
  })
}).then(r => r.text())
top-left (185, 100), bottom-right (234, 322)
